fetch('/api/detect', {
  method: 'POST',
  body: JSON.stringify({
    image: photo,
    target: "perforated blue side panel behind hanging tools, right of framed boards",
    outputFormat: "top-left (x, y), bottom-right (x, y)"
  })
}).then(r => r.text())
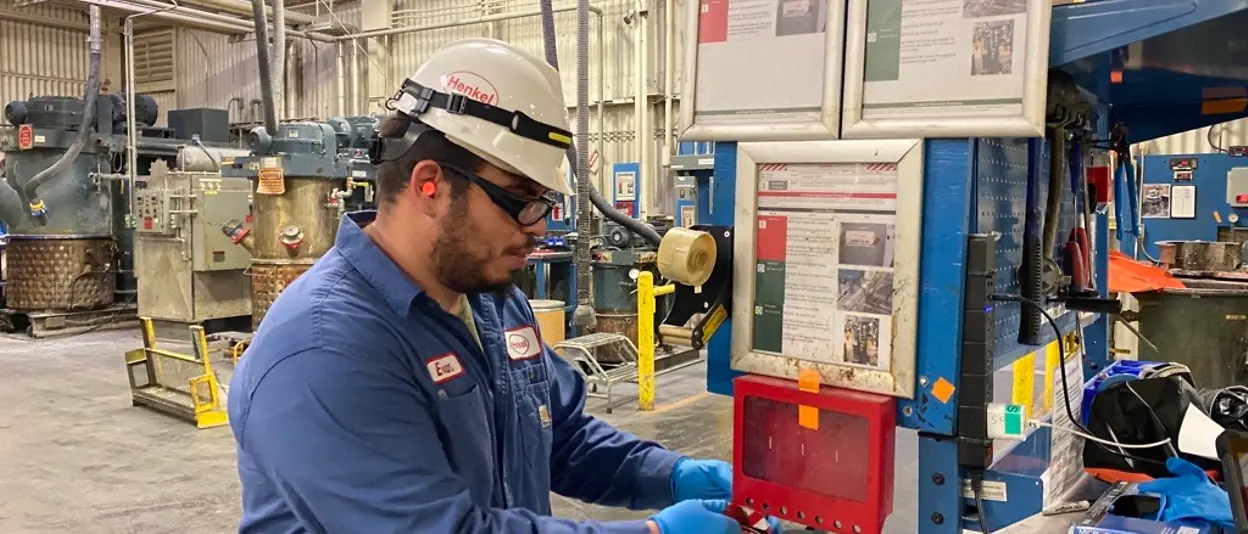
top-left (973, 138), bottom-right (1076, 369)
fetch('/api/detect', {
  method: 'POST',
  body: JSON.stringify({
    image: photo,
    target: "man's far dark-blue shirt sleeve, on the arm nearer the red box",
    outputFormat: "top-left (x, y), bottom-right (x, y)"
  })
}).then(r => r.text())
top-left (545, 347), bottom-right (681, 510)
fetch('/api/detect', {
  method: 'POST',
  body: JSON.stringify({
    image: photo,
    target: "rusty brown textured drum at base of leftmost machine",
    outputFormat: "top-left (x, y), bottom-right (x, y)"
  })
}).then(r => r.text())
top-left (5, 236), bottom-right (117, 311)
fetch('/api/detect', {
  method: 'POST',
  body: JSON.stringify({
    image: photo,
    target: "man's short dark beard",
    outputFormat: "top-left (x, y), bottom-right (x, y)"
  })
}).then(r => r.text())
top-left (432, 198), bottom-right (537, 296)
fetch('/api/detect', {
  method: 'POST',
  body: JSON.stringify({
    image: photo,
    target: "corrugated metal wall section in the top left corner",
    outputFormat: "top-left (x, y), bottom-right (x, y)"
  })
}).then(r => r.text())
top-left (0, 0), bottom-right (90, 124)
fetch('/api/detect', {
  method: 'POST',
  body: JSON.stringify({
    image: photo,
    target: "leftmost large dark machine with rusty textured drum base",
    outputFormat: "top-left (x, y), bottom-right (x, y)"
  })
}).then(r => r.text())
top-left (0, 95), bottom-right (228, 337)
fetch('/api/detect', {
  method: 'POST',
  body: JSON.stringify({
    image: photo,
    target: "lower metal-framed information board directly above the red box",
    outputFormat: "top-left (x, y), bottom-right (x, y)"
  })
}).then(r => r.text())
top-left (733, 140), bottom-right (924, 398)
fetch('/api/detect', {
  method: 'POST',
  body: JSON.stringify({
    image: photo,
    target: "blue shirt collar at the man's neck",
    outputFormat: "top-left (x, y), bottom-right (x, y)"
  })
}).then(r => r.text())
top-left (334, 211), bottom-right (424, 316)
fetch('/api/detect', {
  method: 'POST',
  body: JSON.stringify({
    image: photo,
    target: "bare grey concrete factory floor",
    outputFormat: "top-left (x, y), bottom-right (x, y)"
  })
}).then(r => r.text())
top-left (0, 331), bottom-right (917, 534)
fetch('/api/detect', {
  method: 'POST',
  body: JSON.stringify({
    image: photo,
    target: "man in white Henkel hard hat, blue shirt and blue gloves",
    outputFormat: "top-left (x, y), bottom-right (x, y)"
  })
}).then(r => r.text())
top-left (230, 39), bottom-right (763, 534)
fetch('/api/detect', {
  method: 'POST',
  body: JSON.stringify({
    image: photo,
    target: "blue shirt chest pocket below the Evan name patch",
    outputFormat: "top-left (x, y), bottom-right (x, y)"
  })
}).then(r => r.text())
top-left (437, 386), bottom-right (495, 507)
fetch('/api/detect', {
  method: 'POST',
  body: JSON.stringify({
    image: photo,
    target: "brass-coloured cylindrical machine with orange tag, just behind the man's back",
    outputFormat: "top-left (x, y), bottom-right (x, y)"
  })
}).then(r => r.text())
top-left (220, 122), bottom-right (354, 328)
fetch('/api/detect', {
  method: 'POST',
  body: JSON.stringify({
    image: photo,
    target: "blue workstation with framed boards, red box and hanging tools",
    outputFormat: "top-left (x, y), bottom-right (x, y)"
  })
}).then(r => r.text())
top-left (676, 0), bottom-right (1248, 534)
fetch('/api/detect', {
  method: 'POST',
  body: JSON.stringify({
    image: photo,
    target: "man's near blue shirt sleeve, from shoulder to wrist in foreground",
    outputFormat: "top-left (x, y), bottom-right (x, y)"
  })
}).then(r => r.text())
top-left (237, 349), bottom-right (648, 534)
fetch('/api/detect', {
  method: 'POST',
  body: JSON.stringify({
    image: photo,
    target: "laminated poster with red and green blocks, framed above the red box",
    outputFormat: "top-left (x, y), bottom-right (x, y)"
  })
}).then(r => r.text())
top-left (753, 163), bottom-right (897, 372)
